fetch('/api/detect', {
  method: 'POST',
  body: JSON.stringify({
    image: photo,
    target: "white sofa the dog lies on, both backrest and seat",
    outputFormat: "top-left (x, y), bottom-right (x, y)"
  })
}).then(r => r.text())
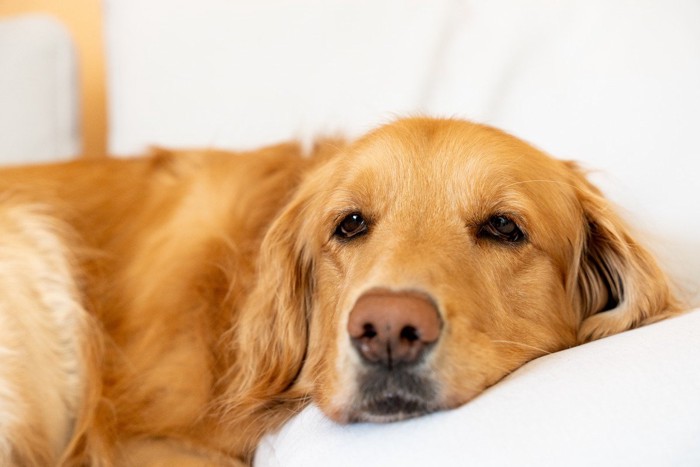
top-left (0, 0), bottom-right (700, 467)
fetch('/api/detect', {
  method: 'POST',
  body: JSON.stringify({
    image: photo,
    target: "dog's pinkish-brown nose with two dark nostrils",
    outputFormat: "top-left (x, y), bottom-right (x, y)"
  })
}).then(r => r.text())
top-left (348, 290), bottom-right (441, 369)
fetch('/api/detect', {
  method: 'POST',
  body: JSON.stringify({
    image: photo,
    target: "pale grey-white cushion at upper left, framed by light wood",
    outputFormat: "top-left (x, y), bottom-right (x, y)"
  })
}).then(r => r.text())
top-left (0, 14), bottom-right (81, 164)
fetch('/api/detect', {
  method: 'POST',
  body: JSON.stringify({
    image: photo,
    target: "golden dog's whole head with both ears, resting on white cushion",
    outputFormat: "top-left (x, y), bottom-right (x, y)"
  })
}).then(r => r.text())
top-left (234, 119), bottom-right (675, 428)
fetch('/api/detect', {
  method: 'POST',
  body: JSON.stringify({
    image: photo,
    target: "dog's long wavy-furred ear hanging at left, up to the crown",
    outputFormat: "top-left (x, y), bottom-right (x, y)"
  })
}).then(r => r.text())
top-left (230, 138), bottom-right (345, 400)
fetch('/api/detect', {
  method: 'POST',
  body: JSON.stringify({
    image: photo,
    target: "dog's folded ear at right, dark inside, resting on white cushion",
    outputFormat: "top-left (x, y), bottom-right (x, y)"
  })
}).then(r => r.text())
top-left (567, 163), bottom-right (680, 342)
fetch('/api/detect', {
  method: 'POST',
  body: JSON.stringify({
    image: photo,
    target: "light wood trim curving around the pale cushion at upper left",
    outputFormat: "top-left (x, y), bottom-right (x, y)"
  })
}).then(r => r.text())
top-left (0, 0), bottom-right (107, 157)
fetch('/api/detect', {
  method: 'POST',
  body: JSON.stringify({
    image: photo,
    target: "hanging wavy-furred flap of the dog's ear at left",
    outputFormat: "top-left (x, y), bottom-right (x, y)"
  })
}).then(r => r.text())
top-left (233, 193), bottom-right (313, 398)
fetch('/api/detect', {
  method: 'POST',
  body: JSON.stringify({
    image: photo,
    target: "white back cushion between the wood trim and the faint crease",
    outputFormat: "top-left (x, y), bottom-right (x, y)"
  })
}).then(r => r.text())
top-left (105, 0), bottom-right (451, 154)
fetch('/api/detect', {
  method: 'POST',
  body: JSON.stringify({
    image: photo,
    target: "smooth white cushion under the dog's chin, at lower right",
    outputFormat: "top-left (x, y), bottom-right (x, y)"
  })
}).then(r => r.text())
top-left (254, 310), bottom-right (700, 467)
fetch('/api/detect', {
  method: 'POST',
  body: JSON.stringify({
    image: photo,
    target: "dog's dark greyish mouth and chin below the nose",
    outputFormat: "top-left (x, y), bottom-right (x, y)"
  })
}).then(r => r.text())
top-left (348, 369), bottom-right (439, 423)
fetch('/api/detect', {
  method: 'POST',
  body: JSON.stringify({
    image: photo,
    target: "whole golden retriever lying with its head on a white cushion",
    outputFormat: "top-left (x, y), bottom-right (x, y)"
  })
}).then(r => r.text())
top-left (0, 118), bottom-right (680, 466)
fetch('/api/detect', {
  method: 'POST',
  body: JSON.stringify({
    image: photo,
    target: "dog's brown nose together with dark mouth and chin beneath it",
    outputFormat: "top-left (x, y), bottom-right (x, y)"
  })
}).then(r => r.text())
top-left (347, 290), bottom-right (442, 422)
